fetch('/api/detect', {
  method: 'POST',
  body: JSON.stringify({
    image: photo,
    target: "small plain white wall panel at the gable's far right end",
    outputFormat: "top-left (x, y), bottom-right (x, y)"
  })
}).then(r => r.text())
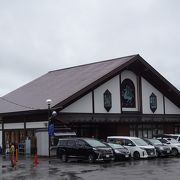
top-left (165, 97), bottom-right (180, 114)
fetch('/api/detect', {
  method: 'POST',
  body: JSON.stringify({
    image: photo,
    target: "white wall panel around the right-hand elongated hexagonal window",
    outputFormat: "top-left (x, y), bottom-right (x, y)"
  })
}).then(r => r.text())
top-left (141, 78), bottom-right (164, 114)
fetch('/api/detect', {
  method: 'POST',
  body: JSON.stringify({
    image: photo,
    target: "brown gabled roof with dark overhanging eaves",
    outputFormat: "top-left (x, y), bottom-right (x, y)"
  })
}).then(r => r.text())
top-left (0, 55), bottom-right (180, 113)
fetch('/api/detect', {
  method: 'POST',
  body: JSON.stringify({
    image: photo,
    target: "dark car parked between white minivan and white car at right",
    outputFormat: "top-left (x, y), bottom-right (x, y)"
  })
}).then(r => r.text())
top-left (143, 138), bottom-right (171, 156)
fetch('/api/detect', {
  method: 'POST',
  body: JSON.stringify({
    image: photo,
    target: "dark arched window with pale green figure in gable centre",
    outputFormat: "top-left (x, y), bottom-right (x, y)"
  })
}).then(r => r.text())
top-left (121, 79), bottom-right (136, 108)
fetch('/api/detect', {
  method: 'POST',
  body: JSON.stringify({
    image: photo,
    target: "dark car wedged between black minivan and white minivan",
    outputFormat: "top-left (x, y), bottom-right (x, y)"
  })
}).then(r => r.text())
top-left (106, 143), bottom-right (131, 161)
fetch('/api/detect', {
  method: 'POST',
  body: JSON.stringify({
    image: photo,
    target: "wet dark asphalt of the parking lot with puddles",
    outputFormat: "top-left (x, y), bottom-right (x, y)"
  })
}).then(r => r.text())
top-left (0, 157), bottom-right (180, 180)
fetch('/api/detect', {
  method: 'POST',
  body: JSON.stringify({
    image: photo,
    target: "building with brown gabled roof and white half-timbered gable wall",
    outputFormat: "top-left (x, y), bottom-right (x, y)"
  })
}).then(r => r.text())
top-left (0, 55), bottom-right (180, 153)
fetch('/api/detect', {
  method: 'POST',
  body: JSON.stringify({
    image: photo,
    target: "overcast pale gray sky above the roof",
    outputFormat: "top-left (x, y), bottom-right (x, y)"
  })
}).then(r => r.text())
top-left (0, 0), bottom-right (180, 96)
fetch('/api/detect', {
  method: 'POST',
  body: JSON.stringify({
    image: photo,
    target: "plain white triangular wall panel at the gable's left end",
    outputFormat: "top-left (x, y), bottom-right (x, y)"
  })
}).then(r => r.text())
top-left (61, 92), bottom-right (92, 113)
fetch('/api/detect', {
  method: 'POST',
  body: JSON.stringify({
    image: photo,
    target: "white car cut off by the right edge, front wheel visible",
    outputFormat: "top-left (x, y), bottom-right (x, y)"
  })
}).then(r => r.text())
top-left (157, 137), bottom-right (180, 156)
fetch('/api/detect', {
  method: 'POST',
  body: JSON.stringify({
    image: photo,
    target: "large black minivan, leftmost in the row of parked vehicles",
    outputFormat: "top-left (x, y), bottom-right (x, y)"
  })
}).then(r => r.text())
top-left (57, 138), bottom-right (114, 163)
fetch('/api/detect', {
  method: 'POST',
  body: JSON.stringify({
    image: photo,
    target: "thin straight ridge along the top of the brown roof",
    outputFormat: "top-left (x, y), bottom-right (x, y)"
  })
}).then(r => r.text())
top-left (48, 54), bottom-right (139, 73)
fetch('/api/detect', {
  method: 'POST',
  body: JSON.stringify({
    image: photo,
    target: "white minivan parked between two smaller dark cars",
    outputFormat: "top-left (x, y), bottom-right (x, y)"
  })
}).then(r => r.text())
top-left (107, 136), bottom-right (156, 159)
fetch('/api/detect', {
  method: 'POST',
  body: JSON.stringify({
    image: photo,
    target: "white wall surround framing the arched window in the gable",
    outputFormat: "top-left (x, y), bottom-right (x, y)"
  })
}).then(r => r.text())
top-left (121, 70), bottom-right (138, 111)
